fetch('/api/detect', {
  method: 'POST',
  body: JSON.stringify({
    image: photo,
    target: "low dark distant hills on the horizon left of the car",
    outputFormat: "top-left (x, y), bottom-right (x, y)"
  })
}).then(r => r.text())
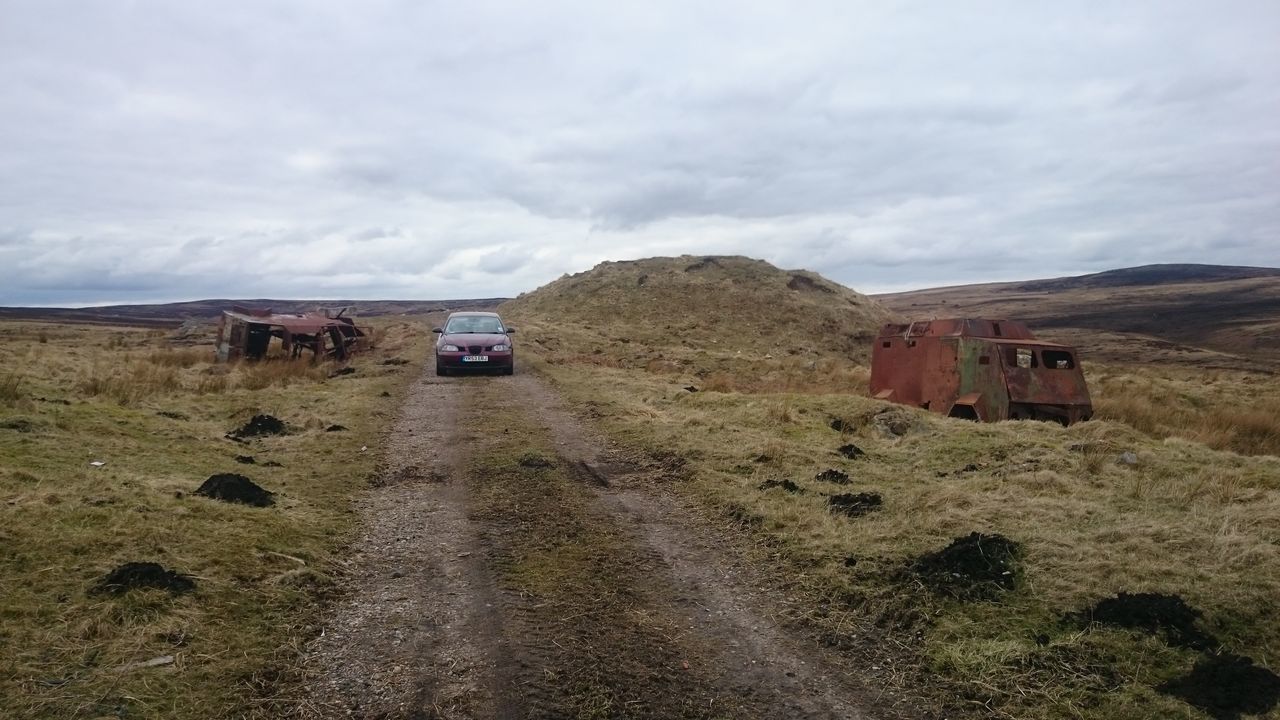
top-left (0, 297), bottom-right (506, 327)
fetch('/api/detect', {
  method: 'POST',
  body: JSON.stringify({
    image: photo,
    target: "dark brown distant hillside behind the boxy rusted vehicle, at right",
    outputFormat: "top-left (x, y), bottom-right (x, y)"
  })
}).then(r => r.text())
top-left (876, 260), bottom-right (1280, 369)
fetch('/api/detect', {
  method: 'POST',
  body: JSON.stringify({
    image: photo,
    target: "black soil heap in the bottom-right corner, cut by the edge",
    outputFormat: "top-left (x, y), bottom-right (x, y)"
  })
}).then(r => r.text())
top-left (1156, 655), bottom-right (1280, 720)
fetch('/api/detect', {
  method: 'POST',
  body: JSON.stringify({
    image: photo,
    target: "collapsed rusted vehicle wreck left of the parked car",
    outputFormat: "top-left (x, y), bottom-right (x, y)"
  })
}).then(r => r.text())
top-left (218, 305), bottom-right (371, 363)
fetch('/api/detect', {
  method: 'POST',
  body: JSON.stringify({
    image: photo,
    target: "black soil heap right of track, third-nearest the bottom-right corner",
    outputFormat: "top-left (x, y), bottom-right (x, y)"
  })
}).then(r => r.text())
top-left (911, 533), bottom-right (1021, 600)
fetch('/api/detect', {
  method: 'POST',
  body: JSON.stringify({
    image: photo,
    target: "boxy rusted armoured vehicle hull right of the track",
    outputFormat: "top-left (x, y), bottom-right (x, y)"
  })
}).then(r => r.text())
top-left (870, 319), bottom-right (1093, 425)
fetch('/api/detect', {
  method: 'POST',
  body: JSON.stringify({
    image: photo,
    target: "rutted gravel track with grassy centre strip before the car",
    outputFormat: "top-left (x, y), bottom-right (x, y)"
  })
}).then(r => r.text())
top-left (303, 366), bottom-right (914, 720)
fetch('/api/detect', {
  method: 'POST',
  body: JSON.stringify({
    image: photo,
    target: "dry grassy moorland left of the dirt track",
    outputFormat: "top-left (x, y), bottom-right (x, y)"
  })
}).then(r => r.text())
top-left (0, 319), bottom-right (429, 717)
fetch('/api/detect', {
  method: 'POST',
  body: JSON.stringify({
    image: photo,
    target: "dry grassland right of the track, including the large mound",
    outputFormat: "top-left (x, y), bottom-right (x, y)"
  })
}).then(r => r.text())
top-left (503, 258), bottom-right (1280, 720)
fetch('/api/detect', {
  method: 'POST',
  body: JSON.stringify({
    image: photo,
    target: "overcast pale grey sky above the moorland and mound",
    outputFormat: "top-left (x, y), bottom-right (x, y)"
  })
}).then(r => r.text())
top-left (0, 0), bottom-right (1280, 305)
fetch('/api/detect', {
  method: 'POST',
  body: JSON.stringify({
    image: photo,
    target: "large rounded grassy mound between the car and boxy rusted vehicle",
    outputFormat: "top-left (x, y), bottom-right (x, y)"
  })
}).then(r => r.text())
top-left (500, 255), bottom-right (896, 392)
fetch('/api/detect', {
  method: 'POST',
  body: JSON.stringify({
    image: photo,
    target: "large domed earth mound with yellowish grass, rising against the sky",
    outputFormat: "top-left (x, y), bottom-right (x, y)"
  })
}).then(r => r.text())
top-left (500, 255), bottom-right (893, 360)
